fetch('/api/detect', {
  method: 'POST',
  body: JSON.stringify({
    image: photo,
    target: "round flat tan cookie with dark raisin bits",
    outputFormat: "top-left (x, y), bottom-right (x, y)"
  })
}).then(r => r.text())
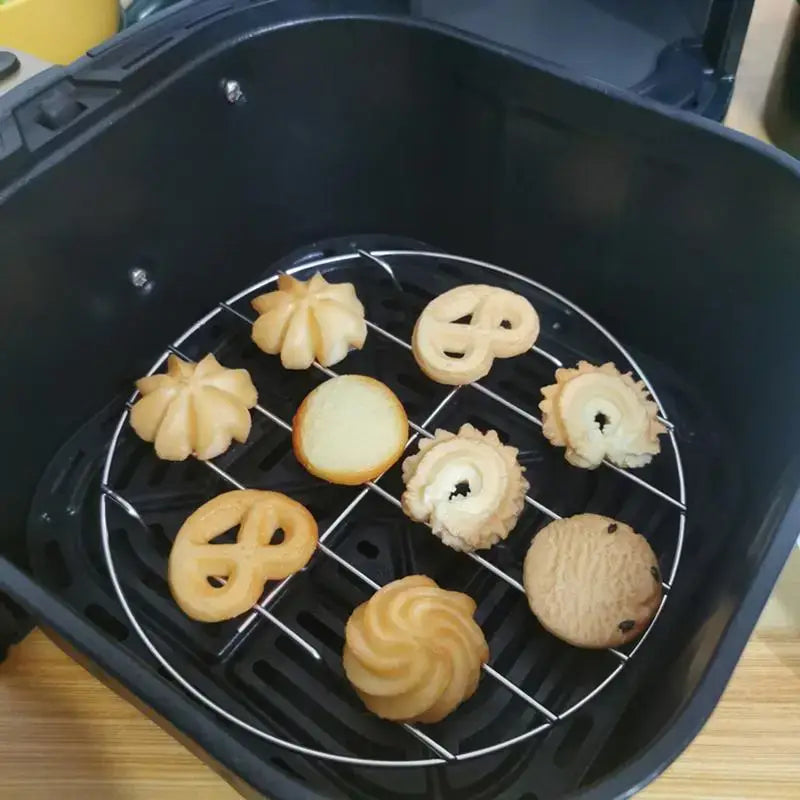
top-left (523, 514), bottom-right (661, 648)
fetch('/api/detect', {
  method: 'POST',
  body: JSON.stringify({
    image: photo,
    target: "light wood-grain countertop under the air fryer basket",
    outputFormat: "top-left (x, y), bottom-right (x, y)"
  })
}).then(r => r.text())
top-left (0, 0), bottom-right (800, 800)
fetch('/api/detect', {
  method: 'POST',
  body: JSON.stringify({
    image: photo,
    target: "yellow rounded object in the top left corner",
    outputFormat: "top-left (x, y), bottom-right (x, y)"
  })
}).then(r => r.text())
top-left (0, 0), bottom-right (120, 64)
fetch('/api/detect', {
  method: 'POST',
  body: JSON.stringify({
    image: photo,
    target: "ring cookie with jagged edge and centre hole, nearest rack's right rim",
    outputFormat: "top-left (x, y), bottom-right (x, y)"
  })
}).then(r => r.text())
top-left (539, 361), bottom-right (667, 469)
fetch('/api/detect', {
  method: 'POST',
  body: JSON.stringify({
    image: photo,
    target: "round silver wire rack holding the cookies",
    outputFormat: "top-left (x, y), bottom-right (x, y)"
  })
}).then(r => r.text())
top-left (99, 249), bottom-right (686, 767)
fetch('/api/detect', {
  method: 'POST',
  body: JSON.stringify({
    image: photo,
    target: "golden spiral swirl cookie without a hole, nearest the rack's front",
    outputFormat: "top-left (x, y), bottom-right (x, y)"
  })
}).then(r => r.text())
top-left (343, 575), bottom-right (489, 723)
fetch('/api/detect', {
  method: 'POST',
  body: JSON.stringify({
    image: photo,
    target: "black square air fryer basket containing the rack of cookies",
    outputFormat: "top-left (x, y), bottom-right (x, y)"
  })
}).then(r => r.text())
top-left (0, 2), bottom-right (800, 800)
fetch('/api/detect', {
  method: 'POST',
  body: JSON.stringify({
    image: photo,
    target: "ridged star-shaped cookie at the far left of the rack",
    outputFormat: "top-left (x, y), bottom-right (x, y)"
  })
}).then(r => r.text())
top-left (131, 353), bottom-right (258, 461)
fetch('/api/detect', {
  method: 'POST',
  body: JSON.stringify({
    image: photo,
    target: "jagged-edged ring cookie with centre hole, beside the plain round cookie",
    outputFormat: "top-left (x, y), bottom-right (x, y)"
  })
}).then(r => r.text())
top-left (402, 423), bottom-right (529, 552)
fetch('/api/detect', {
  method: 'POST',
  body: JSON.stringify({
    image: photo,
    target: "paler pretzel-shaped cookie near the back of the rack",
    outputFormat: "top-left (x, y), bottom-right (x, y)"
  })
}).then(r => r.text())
top-left (412, 284), bottom-right (539, 385)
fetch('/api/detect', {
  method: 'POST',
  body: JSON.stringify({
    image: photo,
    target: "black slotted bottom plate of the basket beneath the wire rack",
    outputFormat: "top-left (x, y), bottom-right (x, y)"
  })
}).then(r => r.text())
top-left (23, 239), bottom-right (733, 797)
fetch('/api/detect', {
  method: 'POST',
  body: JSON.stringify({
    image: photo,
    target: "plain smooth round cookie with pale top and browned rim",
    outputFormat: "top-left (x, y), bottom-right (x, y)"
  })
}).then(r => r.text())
top-left (292, 375), bottom-right (408, 486)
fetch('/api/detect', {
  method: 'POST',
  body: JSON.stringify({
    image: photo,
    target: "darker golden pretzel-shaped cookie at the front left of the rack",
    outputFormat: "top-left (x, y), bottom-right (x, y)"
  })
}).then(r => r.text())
top-left (169, 489), bottom-right (317, 622)
